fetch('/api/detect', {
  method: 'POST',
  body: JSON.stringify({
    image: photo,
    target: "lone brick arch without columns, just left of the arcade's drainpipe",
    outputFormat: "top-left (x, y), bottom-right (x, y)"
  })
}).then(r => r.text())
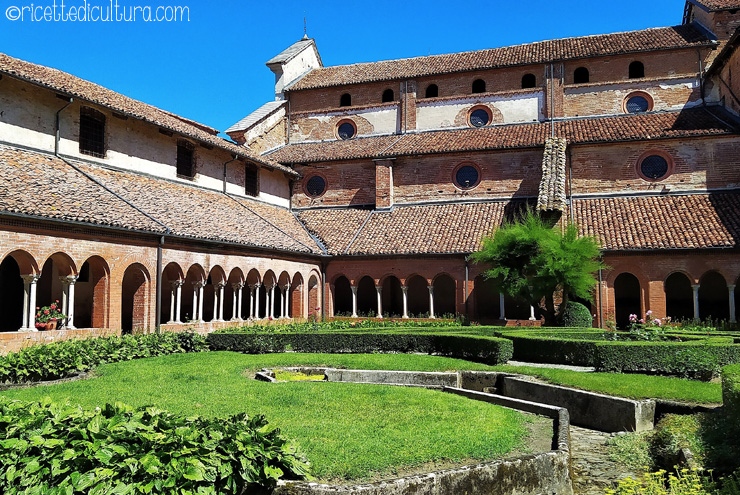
top-left (121, 263), bottom-right (151, 334)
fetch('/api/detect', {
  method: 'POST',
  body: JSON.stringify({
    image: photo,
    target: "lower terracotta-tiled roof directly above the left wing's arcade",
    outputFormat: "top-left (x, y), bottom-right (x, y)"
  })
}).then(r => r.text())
top-left (0, 146), bottom-right (321, 254)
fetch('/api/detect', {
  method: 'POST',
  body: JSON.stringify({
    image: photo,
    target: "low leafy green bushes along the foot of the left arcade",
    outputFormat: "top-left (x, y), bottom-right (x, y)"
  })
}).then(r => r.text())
top-left (0, 332), bottom-right (208, 384)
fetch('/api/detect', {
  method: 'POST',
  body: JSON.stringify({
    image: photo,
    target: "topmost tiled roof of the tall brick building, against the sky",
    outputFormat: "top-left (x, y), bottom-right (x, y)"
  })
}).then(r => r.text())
top-left (286, 25), bottom-right (720, 91)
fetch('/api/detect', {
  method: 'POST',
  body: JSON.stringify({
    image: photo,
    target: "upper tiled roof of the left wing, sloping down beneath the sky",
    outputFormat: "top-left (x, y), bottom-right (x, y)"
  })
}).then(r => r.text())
top-left (0, 53), bottom-right (297, 176)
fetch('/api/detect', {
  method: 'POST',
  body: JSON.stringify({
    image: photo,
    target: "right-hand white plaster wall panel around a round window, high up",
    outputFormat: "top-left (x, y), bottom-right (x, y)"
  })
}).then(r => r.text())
top-left (416, 91), bottom-right (544, 130)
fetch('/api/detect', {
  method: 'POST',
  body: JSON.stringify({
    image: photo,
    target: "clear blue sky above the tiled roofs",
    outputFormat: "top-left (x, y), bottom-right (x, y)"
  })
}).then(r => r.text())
top-left (0, 0), bottom-right (684, 136)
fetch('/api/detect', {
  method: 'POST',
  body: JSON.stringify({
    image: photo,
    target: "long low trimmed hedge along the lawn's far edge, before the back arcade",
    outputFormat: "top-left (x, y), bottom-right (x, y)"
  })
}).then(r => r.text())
top-left (208, 331), bottom-right (513, 364)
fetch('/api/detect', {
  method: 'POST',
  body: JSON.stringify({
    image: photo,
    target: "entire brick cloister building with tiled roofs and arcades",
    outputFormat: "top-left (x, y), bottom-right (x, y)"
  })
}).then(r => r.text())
top-left (0, 0), bottom-right (740, 352)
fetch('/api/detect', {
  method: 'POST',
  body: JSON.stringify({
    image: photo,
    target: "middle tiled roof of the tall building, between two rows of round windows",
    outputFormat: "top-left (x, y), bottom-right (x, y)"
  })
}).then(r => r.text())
top-left (267, 106), bottom-right (740, 164)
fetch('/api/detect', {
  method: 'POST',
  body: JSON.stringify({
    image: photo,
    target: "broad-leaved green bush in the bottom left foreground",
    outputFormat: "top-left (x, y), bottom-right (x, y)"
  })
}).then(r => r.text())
top-left (0, 396), bottom-right (309, 495)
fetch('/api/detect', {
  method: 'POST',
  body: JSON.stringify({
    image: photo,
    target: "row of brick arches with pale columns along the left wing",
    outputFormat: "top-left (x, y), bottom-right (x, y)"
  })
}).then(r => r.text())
top-left (0, 250), bottom-right (321, 333)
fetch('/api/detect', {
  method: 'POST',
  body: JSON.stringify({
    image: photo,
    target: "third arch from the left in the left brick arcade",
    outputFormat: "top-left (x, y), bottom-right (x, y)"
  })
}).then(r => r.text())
top-left (74, 256), bottom-right (110, 328)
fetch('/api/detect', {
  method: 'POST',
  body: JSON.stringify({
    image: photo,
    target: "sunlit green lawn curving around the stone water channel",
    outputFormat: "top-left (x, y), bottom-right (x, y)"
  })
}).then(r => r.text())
top-left (3, 352), bottom-right (529, 481)
